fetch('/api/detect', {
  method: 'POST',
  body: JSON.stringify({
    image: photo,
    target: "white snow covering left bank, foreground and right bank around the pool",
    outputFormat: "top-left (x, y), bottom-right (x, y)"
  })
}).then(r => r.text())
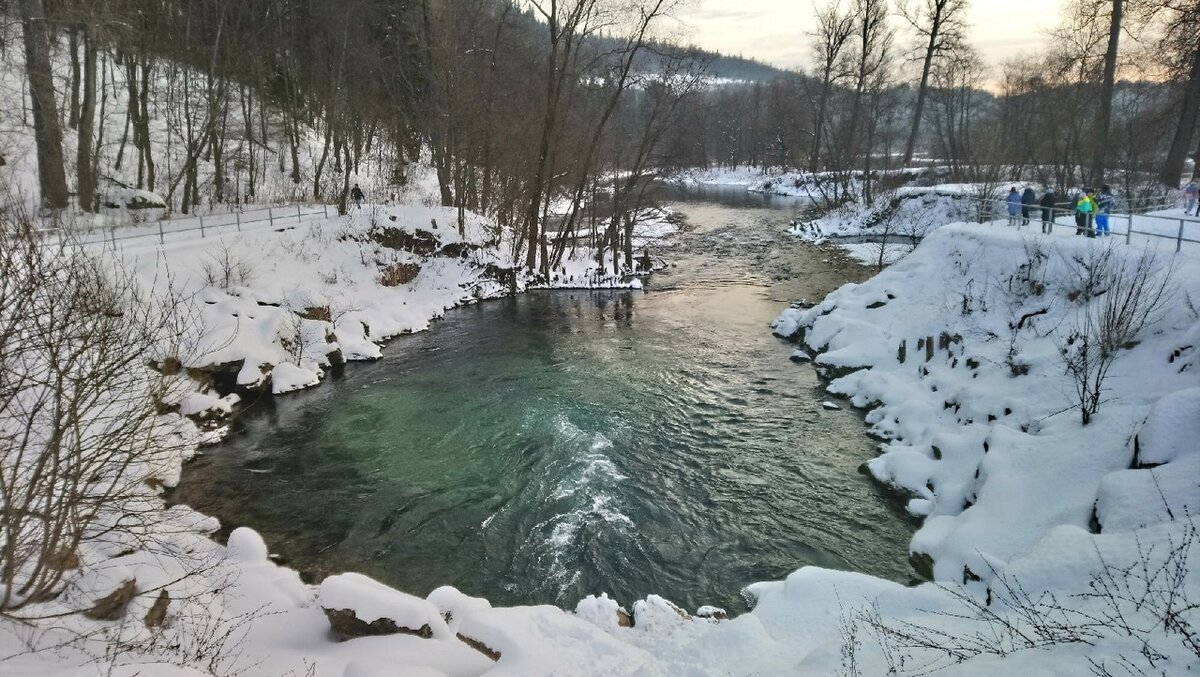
top-left (0, 194), bottom-right (1200, 677)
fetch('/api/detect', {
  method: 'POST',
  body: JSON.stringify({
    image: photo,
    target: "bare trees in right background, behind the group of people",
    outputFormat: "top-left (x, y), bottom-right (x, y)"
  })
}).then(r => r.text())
top-left (674, 0), bottom-right (1200, 200)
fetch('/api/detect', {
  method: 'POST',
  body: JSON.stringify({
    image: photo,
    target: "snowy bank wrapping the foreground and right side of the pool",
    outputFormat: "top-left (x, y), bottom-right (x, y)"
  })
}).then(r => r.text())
top-left (4, 196), bottom-right (1200, 677)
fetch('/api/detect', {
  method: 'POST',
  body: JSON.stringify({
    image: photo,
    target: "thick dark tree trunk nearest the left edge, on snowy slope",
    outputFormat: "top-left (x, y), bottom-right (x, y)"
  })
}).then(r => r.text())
top-left (20, 0), bottom-right (68, 209)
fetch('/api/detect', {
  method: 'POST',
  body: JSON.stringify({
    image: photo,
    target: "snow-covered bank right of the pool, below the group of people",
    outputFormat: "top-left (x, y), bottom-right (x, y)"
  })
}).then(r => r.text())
top-left (775, 224), bottom-right (1200, 675)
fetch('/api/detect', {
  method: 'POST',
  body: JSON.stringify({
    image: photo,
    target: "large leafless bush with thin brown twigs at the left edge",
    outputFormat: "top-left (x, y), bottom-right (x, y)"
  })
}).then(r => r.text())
top-left (0, 221), bottom-right (188, 610)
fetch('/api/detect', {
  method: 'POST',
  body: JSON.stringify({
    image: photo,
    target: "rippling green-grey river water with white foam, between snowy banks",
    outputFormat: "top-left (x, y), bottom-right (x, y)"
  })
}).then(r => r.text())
top-left (173, 184), bottom-right (911, 611)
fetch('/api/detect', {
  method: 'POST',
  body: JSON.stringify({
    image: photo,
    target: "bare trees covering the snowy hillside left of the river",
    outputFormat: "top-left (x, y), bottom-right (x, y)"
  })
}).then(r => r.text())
top-left (10, 0), bottom-right (704, 274)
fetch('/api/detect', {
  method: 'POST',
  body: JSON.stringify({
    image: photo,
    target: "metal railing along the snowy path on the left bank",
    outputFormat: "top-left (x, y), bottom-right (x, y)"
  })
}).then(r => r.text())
top-left (40, 204), bottom-right (336, 250)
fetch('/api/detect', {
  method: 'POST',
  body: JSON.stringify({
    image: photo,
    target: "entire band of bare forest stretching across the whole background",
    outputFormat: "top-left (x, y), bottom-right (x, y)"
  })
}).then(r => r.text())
top-left (0, 0), bottom-right (1200, 272)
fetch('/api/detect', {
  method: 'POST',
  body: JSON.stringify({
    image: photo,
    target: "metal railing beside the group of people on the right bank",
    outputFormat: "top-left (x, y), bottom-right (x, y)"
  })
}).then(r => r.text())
top-left (950, 197), bottom-right (1200, 251)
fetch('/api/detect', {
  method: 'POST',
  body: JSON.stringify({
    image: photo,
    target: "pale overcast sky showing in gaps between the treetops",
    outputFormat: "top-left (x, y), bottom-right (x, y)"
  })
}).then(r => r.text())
top-left (679, 0), bottom-right (1062, 70)
